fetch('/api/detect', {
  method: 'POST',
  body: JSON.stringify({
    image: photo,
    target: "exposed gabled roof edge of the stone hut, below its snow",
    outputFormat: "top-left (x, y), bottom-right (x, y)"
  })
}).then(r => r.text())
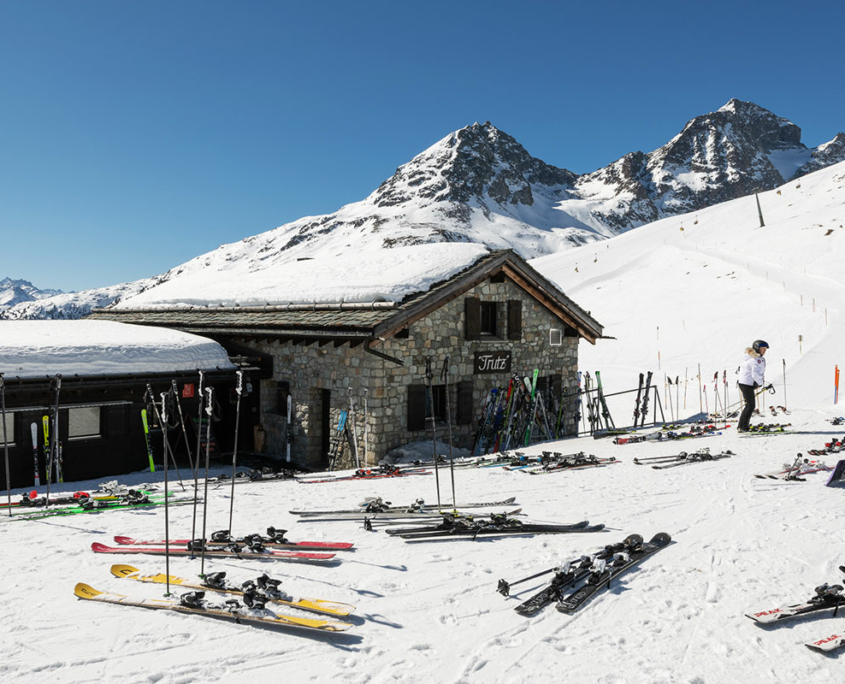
top-left (89, 250), bottom-right (603, 344)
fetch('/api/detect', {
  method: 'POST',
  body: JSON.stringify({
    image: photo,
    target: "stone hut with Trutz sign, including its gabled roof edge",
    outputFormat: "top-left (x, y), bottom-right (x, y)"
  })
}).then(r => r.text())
top-left (92, 250), bottom-right (602, 469)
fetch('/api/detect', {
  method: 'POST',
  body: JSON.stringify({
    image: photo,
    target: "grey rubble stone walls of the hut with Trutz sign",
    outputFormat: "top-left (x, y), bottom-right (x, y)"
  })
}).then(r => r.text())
top-left (240, 280), bottom-right (579, 468)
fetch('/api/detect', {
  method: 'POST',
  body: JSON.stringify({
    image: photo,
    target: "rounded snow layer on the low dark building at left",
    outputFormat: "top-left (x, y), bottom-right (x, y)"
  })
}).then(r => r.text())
top-left (0, 320), bottom-right (235, 378)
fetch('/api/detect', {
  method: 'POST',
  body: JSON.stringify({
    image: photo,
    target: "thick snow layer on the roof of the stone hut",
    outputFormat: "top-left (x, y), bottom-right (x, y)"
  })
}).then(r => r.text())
top-left (115, 242), bottom-right (489, 309)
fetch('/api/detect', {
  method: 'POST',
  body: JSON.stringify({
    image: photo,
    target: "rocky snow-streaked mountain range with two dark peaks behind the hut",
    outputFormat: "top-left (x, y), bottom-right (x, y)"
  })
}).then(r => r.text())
top-left (0, 99), bottom-right (845, 318)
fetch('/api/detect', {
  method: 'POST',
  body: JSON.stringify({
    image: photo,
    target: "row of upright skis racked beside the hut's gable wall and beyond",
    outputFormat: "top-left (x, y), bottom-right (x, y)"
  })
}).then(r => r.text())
top-left (472, 370), bottom-right (666, 456)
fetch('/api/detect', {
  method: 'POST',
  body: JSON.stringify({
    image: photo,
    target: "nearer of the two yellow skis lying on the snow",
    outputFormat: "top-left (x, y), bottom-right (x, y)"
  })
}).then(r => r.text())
top-left (73, 582), bottom-right (352, 632)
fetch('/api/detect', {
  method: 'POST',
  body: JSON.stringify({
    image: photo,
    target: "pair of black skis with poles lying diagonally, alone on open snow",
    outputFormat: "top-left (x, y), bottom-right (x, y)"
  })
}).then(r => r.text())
top-left (497, 532), bottom-right (672, 616)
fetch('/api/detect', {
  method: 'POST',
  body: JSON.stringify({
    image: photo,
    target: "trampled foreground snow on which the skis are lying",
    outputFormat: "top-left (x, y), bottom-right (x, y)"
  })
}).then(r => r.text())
top-left (0, 420), bottom-right (845, 684)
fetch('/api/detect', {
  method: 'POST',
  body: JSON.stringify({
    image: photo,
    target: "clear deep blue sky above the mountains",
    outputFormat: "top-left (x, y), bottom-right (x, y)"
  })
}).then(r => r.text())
top-left (0, 0), bottom-right (845, 290)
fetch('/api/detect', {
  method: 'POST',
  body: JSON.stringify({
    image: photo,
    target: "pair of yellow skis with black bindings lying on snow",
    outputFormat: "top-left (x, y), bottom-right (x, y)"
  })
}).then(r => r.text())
top-left (74, 565), bottom-right (355, 633)
